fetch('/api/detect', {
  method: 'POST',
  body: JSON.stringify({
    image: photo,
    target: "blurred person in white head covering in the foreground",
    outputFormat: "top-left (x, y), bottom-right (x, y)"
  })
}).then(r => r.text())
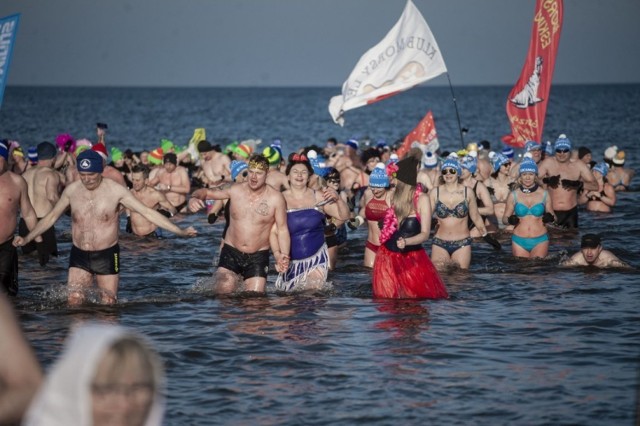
top-left (24, 323), bottom-right (165, 426)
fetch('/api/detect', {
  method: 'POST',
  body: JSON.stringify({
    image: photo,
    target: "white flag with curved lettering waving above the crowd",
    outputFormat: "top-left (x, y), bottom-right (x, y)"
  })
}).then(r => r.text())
top-left (329, 0), bottom-right (447, 126)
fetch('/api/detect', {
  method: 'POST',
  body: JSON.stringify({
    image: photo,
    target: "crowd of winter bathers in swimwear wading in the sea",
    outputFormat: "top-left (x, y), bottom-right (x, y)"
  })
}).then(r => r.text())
top-left (0, 123), bottom-right (634, 303)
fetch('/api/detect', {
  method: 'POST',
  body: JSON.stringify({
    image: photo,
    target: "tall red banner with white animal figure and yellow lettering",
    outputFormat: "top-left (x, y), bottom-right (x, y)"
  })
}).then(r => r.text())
top-left (502, 0), bottom-right (563, 148)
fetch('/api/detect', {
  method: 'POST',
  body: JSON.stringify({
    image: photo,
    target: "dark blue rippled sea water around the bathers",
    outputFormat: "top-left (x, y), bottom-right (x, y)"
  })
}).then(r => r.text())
top-left (0, 85), bottom-right (640, 425)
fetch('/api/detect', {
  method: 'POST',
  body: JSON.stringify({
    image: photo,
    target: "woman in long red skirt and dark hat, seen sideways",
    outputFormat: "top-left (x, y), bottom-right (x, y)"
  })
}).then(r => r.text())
top-left (373, 156), bottom-right (449, 299)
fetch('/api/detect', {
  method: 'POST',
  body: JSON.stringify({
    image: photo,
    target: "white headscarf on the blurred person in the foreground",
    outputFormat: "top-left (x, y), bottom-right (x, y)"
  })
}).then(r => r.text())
top-left (23, 323), bottom-right (164, 426)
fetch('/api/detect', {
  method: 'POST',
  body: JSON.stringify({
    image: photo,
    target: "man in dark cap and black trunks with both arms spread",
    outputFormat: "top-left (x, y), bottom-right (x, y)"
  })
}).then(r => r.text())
top-left (13, 150), bottom-right (197, 305)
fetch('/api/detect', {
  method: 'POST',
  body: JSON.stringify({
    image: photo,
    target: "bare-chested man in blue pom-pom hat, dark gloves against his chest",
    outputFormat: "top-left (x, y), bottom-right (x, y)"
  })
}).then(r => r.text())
top-left (538, 135), bottom-right (598, 229)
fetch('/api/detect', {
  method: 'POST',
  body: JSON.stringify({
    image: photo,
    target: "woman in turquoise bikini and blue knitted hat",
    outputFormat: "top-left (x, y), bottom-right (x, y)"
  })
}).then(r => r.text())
top-left (502, 158), bottom-right (555, 258)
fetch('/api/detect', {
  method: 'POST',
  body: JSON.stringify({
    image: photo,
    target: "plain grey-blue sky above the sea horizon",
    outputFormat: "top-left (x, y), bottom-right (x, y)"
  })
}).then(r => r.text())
top-left (0, 0), bottom-right (640, 87)
